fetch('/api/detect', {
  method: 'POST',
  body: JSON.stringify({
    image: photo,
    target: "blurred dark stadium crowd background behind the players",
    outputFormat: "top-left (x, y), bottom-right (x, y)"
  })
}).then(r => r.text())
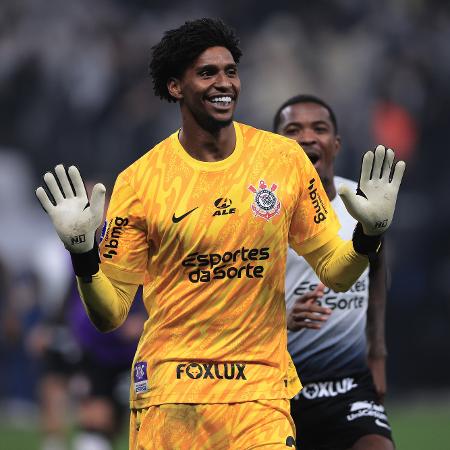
top-left (0, 0), bottom-right (450, 450)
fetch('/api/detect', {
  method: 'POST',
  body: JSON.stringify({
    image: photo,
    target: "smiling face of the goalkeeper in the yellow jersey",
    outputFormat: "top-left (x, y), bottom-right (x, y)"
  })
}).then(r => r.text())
top-left (167, 47), bottom-right (241, 130)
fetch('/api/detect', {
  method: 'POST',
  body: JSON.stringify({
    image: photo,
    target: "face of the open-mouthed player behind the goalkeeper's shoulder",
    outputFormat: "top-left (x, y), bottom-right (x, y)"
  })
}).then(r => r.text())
top-left (278, 103), bottom-right (340, 180)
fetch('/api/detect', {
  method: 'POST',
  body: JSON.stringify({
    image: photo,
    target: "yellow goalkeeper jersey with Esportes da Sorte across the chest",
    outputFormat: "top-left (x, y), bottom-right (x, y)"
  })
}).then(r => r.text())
top-left (100, 122), bottom-right (339, 408)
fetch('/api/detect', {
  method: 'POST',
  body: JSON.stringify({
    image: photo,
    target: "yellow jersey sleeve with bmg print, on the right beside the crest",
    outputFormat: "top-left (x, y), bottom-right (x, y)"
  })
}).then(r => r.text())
top-left (289, 149), bottom-right (340, 255)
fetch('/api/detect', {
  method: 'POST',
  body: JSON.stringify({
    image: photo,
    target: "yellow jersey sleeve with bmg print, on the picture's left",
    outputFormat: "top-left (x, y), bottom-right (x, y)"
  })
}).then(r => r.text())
top-left (100, 173), bottom-right (149, 284)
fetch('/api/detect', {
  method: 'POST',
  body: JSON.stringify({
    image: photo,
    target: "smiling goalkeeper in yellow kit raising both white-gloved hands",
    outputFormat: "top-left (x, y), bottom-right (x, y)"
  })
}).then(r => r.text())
top-left (37, 19), bottom-right (404, 450)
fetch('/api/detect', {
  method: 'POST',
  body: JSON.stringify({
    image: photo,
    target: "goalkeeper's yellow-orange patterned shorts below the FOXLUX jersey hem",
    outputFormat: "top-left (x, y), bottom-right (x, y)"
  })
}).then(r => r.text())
top-left (129, 399), bottom-right (295, 450)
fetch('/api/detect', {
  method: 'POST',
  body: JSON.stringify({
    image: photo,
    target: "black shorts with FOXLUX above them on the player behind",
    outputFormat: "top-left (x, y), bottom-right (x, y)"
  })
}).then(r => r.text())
top-left (291, 371), bottom-right (392, 450)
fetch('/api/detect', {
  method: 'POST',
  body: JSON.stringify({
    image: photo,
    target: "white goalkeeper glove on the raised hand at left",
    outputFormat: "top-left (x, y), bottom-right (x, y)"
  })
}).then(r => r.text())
top-left (36, 164), bottom-right (106, 253)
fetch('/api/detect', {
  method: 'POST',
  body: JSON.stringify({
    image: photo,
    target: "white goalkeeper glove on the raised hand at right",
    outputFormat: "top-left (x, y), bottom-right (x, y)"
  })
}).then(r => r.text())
top-left (338, 145), bottom-right (406, 236)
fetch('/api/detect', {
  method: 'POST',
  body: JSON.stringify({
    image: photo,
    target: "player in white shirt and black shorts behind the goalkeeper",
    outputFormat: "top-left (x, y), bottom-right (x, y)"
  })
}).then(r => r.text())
top-left (274, 95), bottom-right (393, 450)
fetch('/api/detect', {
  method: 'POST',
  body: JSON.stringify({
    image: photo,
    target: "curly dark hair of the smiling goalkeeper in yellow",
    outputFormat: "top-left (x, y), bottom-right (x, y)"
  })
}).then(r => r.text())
top-left (149, 18), bottom-right (242, 102)
